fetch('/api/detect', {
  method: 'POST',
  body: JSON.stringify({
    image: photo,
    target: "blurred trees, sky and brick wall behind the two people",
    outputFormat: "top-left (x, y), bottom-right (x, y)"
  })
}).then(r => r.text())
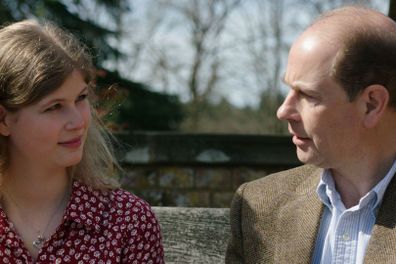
top-left (0, 0), bottom-right (396, 207)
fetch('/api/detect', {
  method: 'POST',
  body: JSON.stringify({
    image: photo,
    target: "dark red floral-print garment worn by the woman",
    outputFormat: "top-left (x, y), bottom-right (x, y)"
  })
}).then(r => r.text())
top-left (0, 181), bottom-right (164, 264)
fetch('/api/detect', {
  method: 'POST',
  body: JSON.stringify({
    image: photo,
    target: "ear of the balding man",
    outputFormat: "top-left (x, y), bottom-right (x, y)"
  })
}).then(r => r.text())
top-left (360, 84), bottom-right (389, 128)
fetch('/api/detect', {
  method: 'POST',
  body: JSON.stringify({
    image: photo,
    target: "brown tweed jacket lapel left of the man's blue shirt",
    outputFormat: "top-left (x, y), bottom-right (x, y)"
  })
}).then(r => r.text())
top-left (275, 169), bottom-right (323, 263)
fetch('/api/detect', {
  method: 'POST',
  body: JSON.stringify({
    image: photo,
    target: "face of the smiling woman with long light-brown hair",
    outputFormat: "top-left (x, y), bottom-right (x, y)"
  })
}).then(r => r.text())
top-left (0, 70), bottom-right (91, 169)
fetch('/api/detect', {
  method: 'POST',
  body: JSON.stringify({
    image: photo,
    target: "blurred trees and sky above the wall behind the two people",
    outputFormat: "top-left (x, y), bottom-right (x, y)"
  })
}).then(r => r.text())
top-left (0, 0), bottom-right (392, 134)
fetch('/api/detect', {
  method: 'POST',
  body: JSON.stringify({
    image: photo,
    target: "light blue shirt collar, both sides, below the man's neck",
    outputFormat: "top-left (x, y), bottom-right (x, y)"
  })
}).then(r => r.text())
top-left (316, 160), bottom-right (396, 209)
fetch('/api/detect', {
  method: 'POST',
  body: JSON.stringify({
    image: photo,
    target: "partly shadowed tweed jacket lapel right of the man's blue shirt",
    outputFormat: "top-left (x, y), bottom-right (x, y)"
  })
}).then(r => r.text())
top-left (364, 172), bottom-right (396, 264)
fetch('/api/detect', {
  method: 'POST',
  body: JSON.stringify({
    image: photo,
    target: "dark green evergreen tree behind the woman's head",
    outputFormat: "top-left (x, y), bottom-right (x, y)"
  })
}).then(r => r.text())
top-left (0, 0), bottom-right (182, 130)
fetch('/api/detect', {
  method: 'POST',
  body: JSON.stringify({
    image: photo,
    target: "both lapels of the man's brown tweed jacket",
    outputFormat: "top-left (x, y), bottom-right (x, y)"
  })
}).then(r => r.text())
top-left (275, 169), bottom-right (396, 264)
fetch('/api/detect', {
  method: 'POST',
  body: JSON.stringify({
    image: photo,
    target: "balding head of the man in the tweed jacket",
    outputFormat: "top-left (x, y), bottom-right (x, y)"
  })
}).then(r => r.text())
top-left (277, 7), bottom-right (396, 167)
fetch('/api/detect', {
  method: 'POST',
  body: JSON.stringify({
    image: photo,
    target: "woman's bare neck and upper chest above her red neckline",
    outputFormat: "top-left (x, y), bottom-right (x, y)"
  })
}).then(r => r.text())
top-left (0, 166), bottom-right (71, 259)
